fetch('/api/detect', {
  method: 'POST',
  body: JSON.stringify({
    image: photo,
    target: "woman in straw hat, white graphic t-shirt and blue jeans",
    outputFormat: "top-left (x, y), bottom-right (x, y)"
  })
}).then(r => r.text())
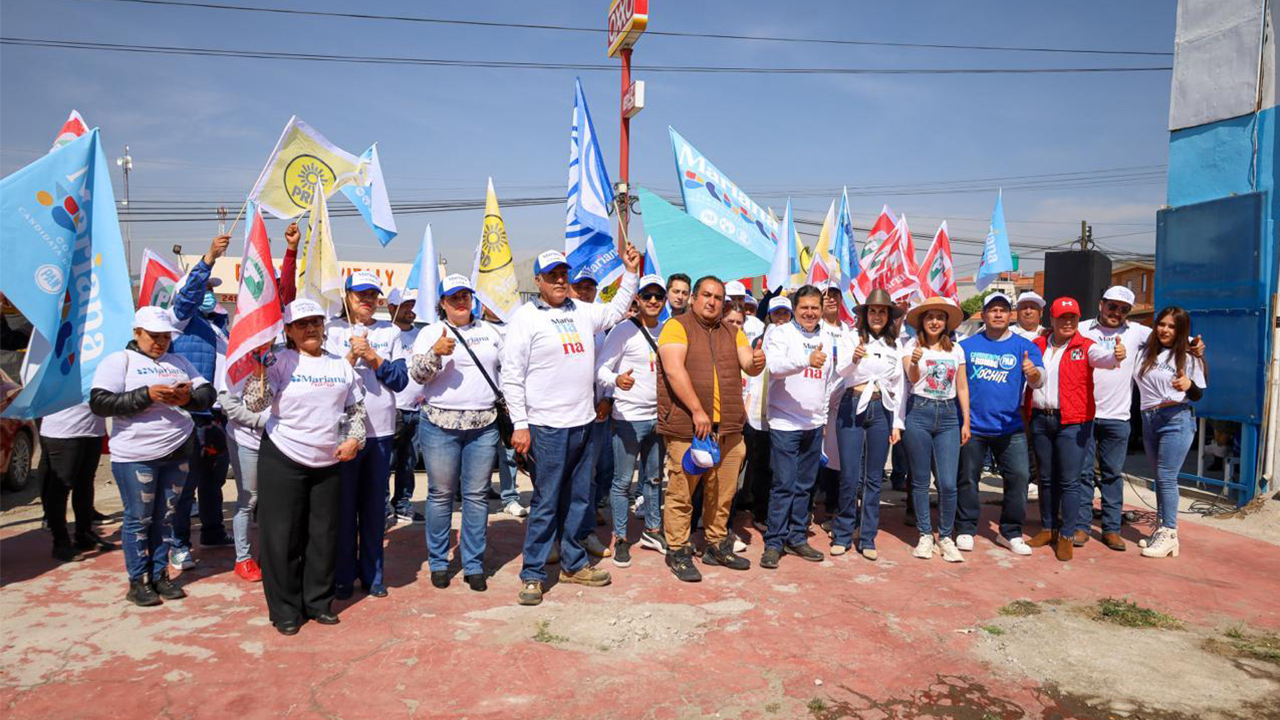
top-left (890, 297), bottom-right (969, 562)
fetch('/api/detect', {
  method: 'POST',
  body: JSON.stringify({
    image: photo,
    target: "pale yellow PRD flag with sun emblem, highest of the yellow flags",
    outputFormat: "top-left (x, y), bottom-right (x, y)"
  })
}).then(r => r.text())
top-left (248, 115), bottom-right (365, 220)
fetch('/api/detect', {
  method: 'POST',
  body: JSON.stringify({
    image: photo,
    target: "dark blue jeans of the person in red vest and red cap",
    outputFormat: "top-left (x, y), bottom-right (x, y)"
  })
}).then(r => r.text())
top-left (1032, 410), bottom-right (1093, 536)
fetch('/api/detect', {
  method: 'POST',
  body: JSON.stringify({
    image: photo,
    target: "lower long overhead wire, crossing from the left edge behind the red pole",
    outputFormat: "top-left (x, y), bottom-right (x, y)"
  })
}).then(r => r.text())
top-left (0, 37), bottom-right (1172, 76)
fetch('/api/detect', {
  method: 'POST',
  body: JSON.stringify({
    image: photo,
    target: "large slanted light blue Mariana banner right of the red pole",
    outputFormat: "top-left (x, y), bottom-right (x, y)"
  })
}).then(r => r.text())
top-left (663, 128), bottom-right (780, 263)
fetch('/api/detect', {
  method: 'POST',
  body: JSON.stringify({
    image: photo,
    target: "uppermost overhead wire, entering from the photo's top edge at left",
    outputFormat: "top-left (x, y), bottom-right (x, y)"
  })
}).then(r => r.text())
top-left (84, 0), bottom-right (1174, 58)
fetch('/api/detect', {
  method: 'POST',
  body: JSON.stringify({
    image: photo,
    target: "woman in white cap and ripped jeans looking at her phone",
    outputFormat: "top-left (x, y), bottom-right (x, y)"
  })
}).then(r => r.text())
top-left (90, 305), bottom-right (218, 606)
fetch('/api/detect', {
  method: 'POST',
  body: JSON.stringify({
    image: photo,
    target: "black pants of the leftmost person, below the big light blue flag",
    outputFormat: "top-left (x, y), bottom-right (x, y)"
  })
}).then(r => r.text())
top-left (40, 436), bottom-right (102, 546)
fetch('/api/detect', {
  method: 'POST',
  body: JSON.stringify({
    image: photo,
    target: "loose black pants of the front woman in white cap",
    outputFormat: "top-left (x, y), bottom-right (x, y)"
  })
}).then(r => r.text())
top-left (257, 436), bottom-right (342, 625)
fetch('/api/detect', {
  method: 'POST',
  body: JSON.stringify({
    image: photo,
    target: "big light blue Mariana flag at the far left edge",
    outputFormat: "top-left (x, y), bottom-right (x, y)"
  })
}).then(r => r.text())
top-left (0, 128), bottom-right (133, 418)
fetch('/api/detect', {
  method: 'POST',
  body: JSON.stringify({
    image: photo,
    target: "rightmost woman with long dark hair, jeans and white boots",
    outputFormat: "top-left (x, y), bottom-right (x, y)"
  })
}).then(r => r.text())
top-left (1133, 305), bottom-right (1208, 557)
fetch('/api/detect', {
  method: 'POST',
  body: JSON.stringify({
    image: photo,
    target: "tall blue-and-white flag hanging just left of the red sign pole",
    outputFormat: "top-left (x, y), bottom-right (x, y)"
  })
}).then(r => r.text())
top-left (564, 79), bottom-right (625, 287)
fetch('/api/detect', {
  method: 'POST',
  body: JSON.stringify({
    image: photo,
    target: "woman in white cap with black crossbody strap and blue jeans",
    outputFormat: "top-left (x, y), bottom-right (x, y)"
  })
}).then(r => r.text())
top-left (410, 274), bottom-right (502, 592)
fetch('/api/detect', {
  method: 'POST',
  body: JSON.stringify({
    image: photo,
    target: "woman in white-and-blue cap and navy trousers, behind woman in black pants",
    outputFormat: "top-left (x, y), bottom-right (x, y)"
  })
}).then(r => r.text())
top-left (325, 270), bottom-right (408, 600)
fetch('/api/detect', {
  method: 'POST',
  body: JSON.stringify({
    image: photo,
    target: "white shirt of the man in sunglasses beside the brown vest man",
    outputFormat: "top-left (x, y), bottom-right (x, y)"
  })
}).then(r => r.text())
top-left (595, 315), bottom-right (658, 421)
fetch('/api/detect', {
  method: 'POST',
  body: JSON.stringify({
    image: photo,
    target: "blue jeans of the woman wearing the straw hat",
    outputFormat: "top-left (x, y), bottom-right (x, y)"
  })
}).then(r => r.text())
top-left (902, 396), bottom-right (960, 538)
